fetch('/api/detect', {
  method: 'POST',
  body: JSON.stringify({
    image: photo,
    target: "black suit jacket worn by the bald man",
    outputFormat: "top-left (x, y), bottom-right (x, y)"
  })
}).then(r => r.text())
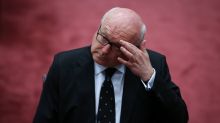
top-left (33, 47), bottom-right (188, 123)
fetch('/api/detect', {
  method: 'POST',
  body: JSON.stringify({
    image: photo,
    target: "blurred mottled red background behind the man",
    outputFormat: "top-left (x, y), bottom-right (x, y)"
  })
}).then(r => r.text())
top-left (0, 0), bottom-right (220, 123)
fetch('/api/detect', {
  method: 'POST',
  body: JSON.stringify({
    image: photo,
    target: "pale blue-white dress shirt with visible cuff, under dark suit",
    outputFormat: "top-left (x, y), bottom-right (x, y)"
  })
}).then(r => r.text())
top-left (94, 63), bottom-right (156, 123)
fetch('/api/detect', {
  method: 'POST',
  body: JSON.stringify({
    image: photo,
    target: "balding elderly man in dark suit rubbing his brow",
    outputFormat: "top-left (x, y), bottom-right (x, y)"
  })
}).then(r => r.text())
top-left (33, 8), bottom-right (188, 123)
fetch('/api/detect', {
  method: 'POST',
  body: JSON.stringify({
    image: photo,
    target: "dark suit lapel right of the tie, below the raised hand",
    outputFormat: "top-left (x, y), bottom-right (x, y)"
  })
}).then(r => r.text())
top-left (120, 68), bottom-right (140, 123)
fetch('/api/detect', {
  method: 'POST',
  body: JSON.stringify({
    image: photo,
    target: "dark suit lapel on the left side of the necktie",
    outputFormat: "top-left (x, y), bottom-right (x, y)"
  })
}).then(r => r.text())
top-left (75, 48), bottom-right (95, 123)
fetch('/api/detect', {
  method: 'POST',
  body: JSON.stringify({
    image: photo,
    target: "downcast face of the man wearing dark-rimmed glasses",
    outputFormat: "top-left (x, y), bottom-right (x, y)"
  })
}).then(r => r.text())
top-left (91, 25), bottom-right (139, 67)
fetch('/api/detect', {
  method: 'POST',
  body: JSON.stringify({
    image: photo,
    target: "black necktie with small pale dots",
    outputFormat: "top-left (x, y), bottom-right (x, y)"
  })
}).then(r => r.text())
top-left (97, 68), bottom-right (116, 123)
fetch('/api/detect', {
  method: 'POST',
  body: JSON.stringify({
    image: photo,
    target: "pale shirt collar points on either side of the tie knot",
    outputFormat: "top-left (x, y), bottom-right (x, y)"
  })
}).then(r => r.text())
top-left (94, 62), bottom-right (125, 75)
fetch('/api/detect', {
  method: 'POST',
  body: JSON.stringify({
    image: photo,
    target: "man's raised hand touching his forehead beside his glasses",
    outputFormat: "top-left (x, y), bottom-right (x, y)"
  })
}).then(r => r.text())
top-left (118, 40), bottom-right (154, 81)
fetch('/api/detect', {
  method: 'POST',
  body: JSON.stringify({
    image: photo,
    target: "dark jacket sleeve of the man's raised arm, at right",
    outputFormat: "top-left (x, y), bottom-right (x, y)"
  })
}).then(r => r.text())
top-left (151, 56), bottom-right (188, 123)
